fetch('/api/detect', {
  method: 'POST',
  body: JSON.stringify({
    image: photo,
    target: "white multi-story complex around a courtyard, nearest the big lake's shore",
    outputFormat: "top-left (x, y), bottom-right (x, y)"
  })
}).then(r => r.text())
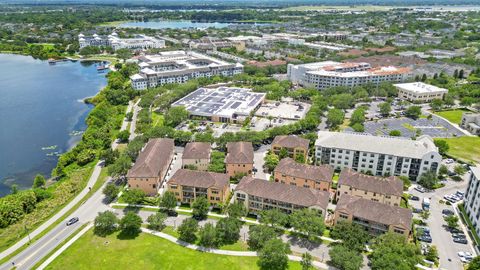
top-left (130, 51), bottom-right (243, 90)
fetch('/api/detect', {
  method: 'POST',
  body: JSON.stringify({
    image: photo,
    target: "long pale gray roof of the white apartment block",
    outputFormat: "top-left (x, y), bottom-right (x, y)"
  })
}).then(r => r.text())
top-left (315, 131), bottom-right (438, 159)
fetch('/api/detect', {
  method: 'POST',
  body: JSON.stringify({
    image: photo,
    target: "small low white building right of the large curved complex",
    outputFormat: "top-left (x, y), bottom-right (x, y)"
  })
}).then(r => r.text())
top-left (394, 82), bottom-right (448, 102)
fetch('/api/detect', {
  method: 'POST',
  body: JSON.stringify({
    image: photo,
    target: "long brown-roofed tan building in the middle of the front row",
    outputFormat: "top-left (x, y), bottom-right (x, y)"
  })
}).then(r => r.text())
top-left (234, 176), bottom-right (330, 217)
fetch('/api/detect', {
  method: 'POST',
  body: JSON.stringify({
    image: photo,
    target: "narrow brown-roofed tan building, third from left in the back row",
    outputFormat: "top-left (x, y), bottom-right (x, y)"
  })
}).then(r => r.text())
top-left (225, 142), bottom-right (253, 177)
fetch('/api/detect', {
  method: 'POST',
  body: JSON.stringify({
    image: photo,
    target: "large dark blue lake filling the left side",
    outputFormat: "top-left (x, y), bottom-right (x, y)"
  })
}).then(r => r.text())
top-left (0, 54), bottom-right (106, 196)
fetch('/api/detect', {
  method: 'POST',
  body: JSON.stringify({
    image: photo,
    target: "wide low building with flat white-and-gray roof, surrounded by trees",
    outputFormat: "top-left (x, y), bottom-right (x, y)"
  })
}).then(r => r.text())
top-left (172, 87), bottom-right (265, 123)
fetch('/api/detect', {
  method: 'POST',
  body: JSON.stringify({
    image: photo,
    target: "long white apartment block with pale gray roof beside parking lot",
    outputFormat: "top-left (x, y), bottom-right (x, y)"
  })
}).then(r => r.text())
top-left (315, 131), bottom-right (442, 180)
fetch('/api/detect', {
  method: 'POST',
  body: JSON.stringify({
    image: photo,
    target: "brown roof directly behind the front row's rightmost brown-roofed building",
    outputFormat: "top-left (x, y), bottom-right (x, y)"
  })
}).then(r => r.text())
top-left (338, 168), bottom-right (403, 197)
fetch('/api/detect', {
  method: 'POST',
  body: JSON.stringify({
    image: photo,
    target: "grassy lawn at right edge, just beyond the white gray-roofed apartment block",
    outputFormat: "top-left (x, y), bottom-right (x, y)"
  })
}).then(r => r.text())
top-left (442, 136), bottom-right (480, 163)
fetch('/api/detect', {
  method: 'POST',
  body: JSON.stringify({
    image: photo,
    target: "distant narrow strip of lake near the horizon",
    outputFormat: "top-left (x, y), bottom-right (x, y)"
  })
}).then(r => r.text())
top-left (119, 20), bottom-right (265, 29)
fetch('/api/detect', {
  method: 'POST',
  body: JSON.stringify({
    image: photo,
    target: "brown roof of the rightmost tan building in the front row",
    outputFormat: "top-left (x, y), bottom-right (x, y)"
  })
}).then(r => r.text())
top-left (335, 194), bottom-right (412, 230)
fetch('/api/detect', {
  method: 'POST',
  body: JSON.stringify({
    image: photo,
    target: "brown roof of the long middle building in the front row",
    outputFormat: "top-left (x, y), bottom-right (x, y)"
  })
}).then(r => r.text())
top-left (235, 176), bottom-right (330, 209)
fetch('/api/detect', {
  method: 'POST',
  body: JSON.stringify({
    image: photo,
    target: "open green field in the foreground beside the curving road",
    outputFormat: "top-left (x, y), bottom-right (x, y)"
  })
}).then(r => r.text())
top-left (47, 230), bottom-right (301, 270)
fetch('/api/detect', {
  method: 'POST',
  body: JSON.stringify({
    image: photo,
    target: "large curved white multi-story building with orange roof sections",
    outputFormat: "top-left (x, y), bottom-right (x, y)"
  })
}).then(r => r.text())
top-left (287, 61), bottom-right (412, 89)
